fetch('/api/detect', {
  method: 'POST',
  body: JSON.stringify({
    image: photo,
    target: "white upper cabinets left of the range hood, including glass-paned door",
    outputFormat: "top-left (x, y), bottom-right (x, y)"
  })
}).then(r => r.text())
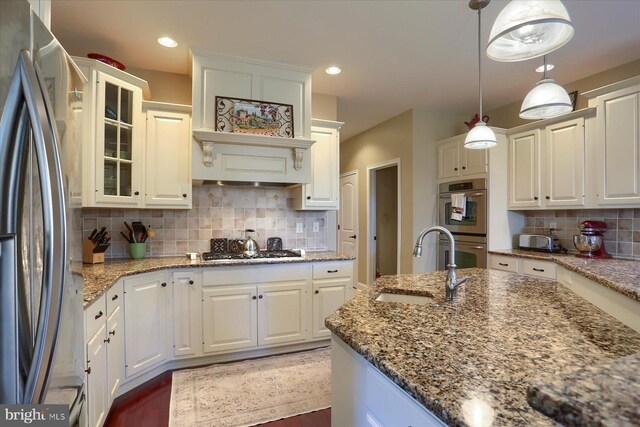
top-left (73, 58), bottom-right (191, 208)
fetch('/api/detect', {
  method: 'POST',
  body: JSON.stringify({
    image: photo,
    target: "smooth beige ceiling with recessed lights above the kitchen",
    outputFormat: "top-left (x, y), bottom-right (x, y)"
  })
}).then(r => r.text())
top-left (52, 0), bottom-right (640, 140)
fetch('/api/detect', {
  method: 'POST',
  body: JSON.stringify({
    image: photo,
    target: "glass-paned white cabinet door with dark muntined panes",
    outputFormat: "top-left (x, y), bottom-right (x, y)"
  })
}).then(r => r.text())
top-left (96, 73), bottom-right (142, 206)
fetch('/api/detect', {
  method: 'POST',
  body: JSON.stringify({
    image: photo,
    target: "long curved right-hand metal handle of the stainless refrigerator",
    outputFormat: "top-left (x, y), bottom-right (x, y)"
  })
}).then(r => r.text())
top-left (18, 50), bottom-right (66, 403)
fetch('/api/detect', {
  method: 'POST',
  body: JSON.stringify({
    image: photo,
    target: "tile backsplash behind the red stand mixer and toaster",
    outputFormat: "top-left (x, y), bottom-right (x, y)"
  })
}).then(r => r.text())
top-left (523, 209), bottom-right (640, 259)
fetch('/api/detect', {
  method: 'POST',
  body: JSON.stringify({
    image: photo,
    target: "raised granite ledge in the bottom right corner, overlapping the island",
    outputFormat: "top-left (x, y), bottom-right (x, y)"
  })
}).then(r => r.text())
top-left (527, 354), bottom-right (640, 427)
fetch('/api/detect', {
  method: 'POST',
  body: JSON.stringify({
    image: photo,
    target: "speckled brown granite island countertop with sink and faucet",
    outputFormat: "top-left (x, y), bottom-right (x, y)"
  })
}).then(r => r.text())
top-left (326, 268), bottom-right (640, 426)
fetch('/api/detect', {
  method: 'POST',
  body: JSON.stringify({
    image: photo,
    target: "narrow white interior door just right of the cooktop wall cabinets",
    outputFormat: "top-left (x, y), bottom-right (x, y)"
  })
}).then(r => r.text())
top-left (338, 172), bottom-right (358, 283)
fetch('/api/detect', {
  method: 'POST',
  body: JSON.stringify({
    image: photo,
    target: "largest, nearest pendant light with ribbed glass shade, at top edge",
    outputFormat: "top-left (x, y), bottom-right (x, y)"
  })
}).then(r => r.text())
top-left (487, 0), bottom-right (574, 62)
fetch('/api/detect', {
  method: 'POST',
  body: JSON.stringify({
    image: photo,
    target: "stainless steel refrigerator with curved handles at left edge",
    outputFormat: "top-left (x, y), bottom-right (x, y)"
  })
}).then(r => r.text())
top-left (0, 0), bottom-right (85, 424)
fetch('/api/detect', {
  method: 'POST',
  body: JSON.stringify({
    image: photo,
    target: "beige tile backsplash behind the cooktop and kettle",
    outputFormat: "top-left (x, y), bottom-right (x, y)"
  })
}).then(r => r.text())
top-left (83, 185), bottom-right (328, 258)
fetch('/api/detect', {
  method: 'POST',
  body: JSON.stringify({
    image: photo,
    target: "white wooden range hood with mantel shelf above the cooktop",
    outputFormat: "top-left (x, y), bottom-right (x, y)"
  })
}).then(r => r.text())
top-left (192, 49), bottom-right (314, 184)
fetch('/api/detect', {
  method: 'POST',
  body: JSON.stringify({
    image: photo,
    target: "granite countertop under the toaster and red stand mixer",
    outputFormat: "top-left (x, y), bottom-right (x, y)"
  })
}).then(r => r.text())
top-left (489, 249), bottom-right (640, 301)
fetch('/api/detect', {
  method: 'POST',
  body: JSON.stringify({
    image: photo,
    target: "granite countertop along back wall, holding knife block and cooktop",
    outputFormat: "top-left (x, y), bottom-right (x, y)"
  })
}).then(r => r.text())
top-left (81, 251), bottom-right (353, 307)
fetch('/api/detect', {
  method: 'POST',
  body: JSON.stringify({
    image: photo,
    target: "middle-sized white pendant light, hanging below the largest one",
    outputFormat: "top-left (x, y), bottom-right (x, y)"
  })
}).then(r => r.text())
top-left (520, 55), bottom-right (573, 120)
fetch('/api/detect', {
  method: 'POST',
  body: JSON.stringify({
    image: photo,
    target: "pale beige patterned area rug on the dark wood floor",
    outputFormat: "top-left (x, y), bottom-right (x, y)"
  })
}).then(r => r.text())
top-left (169, 348), bottom-right (331, 427)
